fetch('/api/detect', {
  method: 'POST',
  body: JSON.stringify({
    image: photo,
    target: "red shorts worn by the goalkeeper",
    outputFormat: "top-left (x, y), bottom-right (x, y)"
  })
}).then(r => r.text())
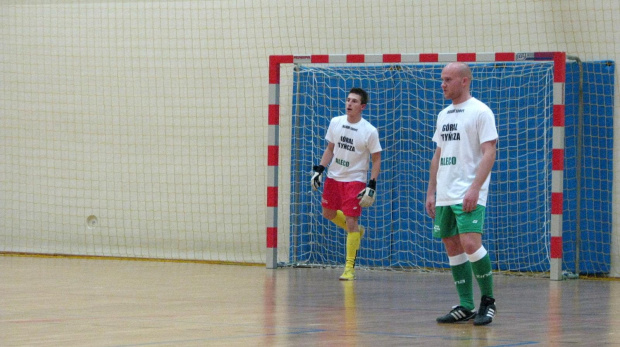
top-left (321, 178), bottom-right (366, 217)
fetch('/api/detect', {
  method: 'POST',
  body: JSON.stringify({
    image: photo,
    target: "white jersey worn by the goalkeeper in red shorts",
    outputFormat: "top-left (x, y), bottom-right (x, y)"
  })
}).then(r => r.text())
top-left (325, 115), bottom-right (382, 182)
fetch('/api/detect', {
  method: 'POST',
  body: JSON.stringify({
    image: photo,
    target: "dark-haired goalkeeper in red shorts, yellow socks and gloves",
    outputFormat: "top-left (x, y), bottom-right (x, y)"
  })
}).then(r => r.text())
top-left (310, 88), bottom-right (382, 281)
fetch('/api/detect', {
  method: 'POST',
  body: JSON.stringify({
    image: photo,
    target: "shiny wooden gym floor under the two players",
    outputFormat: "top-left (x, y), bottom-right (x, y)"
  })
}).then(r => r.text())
top-left (0, 256), bottom-right (620, 347)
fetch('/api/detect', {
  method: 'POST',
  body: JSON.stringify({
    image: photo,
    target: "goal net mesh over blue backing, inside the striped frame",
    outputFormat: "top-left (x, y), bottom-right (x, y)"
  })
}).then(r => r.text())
top-left (279, 61), bottom-right (553, 272)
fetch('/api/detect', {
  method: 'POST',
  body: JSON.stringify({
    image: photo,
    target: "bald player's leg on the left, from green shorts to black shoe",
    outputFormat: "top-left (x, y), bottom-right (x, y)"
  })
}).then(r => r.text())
top-left (433, 206), bottom-right (476, 323)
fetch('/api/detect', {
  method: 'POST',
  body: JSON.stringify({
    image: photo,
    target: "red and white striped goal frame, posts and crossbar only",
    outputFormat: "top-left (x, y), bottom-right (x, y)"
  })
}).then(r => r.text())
top-left (266, 52), bottom-right (566, 280)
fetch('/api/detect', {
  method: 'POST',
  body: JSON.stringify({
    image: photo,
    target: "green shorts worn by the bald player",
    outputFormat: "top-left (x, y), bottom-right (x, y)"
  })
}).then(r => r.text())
top-left (433, 204), bottom-right (486, 239)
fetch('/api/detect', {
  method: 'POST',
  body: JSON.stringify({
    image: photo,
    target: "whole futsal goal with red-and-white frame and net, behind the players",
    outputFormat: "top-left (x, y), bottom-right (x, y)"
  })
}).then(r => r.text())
top-left (266, 52), bottom-right (616, 280)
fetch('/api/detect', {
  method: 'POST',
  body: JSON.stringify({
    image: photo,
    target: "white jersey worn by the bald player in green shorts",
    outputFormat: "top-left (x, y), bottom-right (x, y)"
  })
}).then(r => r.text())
top-left (433, 97), bottom-right (498, 206)
